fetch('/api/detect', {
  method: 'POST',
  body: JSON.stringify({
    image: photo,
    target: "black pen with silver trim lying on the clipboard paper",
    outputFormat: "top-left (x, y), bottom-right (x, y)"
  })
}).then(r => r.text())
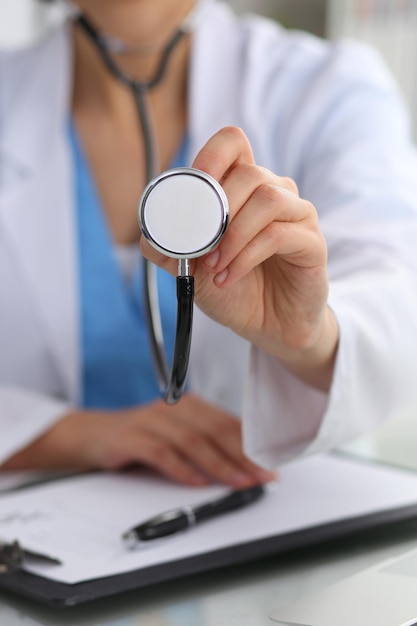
top-left (122, 485), bottom-right (266, 548)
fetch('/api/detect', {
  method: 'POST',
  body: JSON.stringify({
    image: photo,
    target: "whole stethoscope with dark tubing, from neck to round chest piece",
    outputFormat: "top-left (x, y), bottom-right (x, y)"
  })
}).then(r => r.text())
top-left (75, 0), bottom-right (229, 404)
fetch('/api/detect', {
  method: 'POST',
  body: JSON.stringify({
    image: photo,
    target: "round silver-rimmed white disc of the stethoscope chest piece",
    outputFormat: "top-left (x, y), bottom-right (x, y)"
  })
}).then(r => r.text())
top-left (139, 167), bottom-right (229, 259)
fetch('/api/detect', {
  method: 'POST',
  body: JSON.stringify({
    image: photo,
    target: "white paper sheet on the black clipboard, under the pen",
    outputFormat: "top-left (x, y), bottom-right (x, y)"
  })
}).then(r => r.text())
top-left (0, 455), bottom-right (417, 583)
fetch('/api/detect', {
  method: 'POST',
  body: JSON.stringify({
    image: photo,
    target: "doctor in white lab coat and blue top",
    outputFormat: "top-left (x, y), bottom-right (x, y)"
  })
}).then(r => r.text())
top-left (0, 0), bottom-right (417, 486)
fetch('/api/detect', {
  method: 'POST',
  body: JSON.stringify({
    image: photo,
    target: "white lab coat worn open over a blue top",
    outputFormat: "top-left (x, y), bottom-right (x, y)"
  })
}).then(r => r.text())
top-left (0, 3), bottom-right (417, 466)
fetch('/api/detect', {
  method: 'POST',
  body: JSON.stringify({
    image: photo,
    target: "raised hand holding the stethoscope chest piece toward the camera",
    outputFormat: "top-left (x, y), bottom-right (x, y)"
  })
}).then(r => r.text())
top-left (141, 127), bottom-right (338, 389)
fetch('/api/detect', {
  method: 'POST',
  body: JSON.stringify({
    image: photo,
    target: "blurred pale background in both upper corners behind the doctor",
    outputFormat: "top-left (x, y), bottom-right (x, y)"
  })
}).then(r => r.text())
top-left (0, 0), bottom-right (417, 137)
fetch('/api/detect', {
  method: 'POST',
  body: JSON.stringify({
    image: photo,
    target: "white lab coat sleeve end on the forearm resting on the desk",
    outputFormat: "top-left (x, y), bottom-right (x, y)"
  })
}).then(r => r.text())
top-left (0, 385), bottom-right (71, 463)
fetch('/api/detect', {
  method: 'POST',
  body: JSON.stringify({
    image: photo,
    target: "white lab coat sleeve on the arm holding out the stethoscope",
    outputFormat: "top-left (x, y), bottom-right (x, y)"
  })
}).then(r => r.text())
top-left (243, 40), bottom-right (417, 467)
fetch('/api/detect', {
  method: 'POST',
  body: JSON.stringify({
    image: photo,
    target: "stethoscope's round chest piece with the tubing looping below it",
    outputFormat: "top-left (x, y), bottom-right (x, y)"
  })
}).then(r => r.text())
top-left (138, 167), bottom-right (229, 404)
